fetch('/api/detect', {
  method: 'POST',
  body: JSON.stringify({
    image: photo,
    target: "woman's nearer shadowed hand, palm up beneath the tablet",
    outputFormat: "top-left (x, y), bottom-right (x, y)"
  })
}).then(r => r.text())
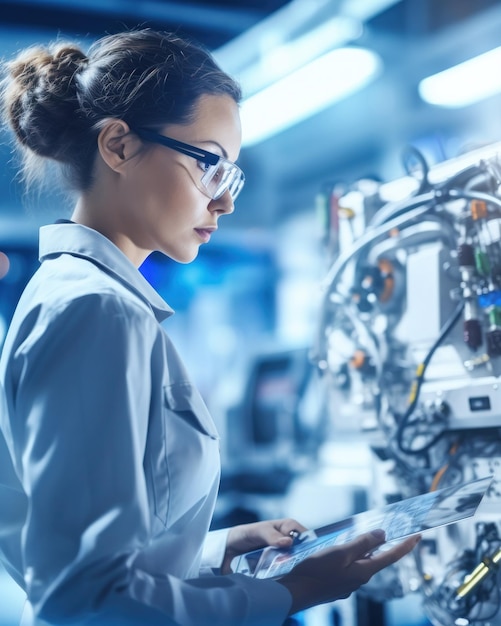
top-left (278, 531), bottom-right (420, 615)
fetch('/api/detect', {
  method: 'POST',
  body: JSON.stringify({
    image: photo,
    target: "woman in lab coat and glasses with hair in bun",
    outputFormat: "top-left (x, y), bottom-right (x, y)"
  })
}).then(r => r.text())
top-left (0, 29), bottom-right (415, 626)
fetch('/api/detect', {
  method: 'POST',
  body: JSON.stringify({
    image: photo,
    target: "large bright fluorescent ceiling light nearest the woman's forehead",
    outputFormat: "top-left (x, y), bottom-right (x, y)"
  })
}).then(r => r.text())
top-left (241, 48), bottom-right (382, 146)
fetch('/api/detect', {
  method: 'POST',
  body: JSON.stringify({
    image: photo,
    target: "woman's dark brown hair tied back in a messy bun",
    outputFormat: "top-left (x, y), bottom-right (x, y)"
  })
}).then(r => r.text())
top-left (2, 29), bottom-right (241, 190)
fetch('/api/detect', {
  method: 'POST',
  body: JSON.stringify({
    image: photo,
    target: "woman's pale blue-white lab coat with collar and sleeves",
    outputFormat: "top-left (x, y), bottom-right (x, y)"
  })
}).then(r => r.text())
top-left (0, 224), bottom-right (291, 626)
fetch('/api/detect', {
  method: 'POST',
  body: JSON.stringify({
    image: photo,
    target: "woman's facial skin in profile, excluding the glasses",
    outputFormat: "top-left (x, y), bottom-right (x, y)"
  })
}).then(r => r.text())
top-left (111, 95), bottom-right (241, 265)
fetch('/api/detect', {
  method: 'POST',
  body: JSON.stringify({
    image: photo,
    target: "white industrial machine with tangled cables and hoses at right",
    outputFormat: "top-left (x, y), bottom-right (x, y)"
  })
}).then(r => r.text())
top-left (312, 144), bottom-right (501, 626)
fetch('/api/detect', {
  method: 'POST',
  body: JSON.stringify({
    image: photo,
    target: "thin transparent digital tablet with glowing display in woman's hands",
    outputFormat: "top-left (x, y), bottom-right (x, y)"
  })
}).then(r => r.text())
top-left (231, 476), bottom-right (493, 578)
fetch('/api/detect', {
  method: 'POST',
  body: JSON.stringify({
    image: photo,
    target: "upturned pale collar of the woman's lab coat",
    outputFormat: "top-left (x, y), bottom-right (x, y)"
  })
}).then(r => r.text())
top-left (39, 222), bottom-right (174, 322)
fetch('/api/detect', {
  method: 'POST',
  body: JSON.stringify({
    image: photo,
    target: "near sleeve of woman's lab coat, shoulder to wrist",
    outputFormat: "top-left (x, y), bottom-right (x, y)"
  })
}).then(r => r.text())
top-left (7, 294), bottom-right (291, 626)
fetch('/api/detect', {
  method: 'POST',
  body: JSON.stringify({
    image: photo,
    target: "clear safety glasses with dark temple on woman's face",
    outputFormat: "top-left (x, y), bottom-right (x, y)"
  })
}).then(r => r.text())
top-left (133, 128), bottom-right (245, 202)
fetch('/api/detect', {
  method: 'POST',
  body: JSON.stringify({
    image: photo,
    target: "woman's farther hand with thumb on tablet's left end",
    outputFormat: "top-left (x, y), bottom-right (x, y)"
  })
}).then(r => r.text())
top-left (221, 518), bottom-right (306, 574)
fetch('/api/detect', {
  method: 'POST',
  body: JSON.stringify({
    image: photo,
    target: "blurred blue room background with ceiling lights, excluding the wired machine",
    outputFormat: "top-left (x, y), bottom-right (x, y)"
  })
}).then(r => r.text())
top-left (0, 0), bottom-right (501, 626)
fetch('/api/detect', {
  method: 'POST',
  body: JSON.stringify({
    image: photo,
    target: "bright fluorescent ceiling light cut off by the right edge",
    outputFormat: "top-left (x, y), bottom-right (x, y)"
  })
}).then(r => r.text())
top-left (419, 47), bottom-right (501, 108)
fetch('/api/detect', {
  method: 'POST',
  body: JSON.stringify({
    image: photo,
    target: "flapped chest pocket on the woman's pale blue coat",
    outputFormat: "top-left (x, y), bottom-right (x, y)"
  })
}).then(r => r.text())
top-left (151, 383), bottom-right (220, 526)
